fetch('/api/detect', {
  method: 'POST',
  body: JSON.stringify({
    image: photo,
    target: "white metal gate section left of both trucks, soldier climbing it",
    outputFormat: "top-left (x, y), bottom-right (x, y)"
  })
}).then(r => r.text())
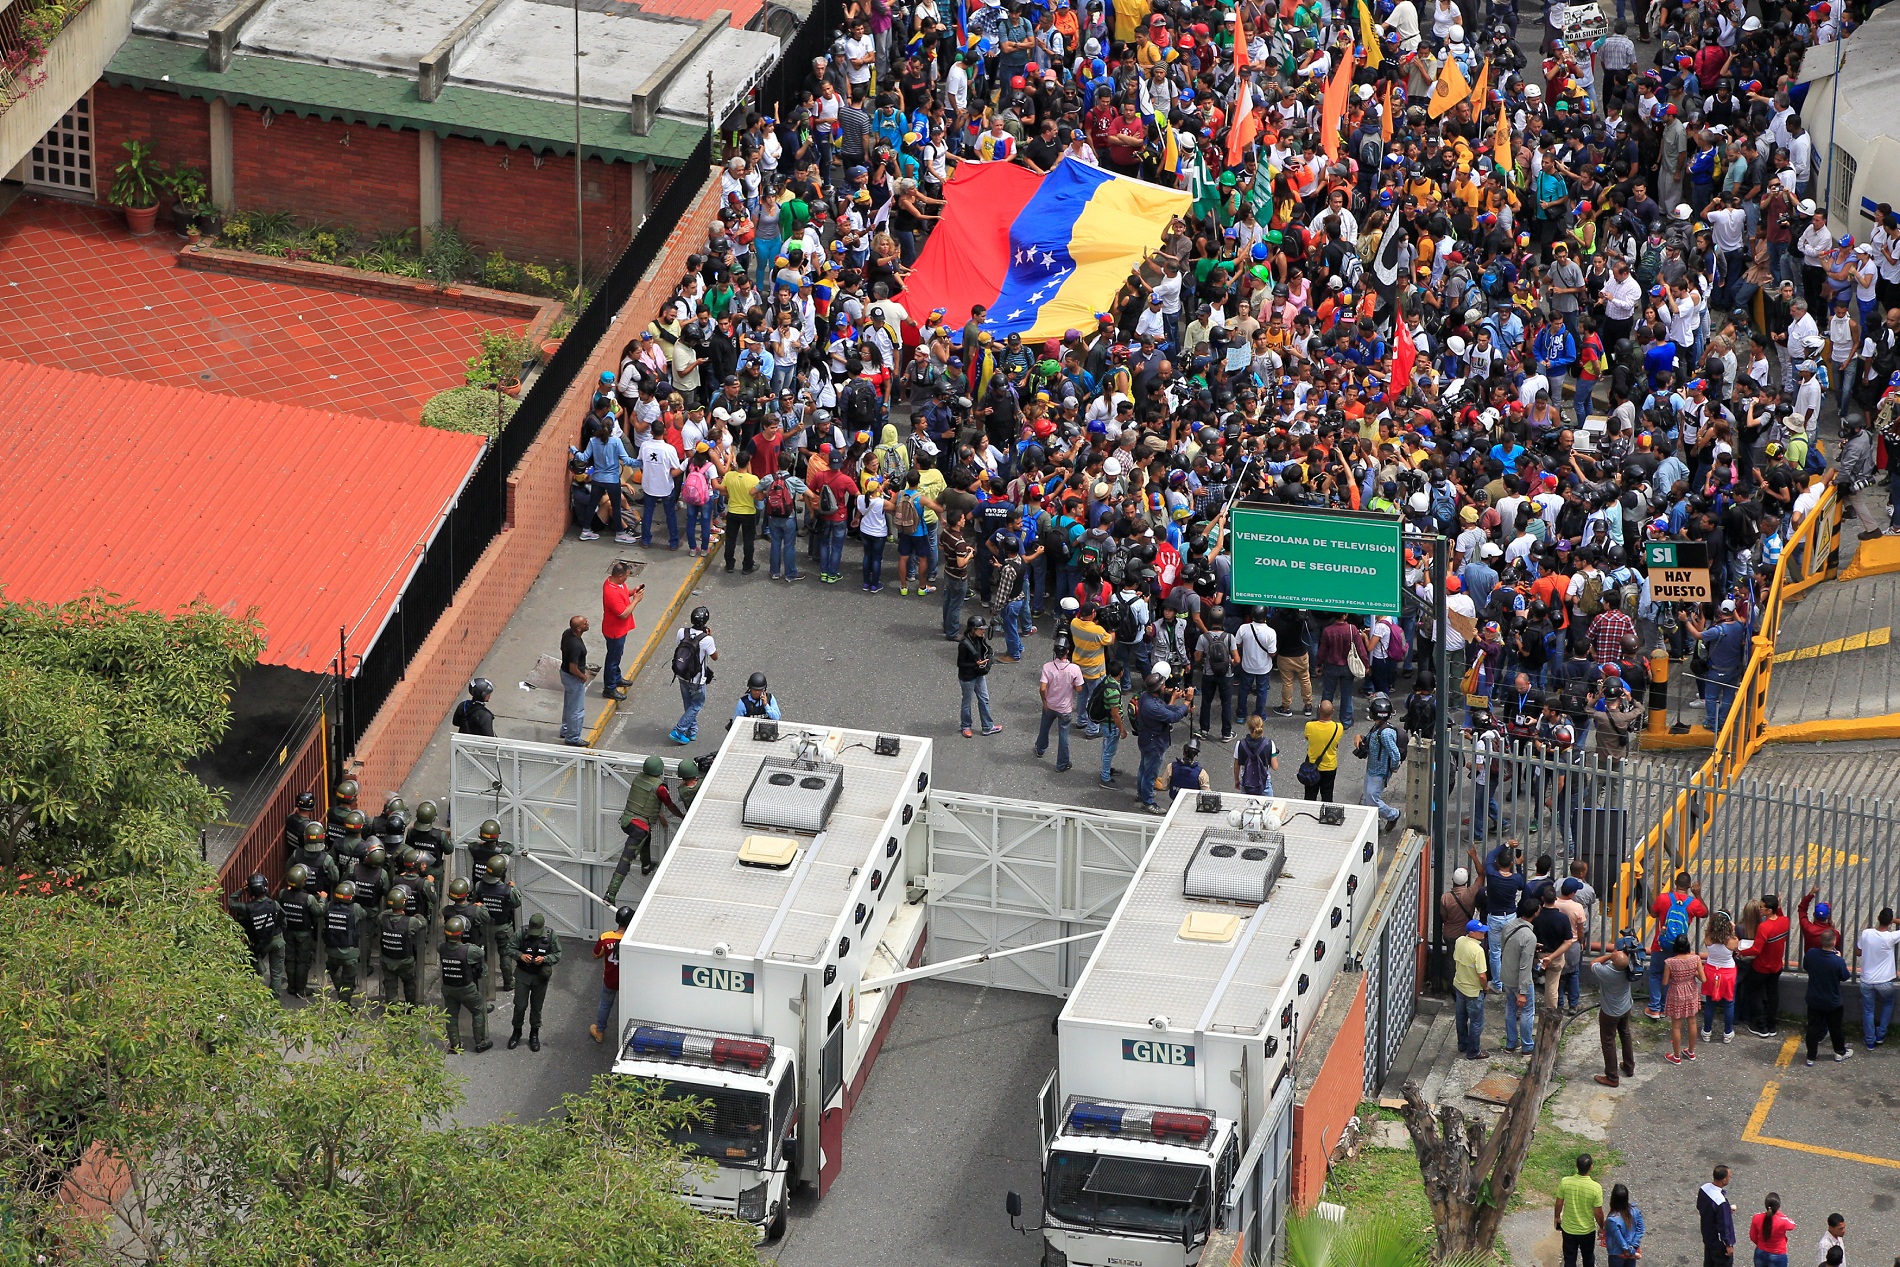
top-left (448, 735), bottom-right (695, 938)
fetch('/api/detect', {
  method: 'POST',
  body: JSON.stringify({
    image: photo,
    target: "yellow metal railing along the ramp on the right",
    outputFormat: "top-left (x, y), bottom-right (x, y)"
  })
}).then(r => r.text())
top-left (1617, 488), bottom-right (1841, 940)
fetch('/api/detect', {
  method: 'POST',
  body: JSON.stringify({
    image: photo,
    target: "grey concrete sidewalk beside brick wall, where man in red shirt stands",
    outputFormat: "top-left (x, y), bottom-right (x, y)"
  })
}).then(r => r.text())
top-left (393, 530), bottom-right (718, 813)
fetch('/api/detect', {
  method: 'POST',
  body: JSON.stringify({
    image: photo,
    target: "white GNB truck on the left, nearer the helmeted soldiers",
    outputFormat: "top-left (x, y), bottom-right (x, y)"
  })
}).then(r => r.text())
top-left (614, 720), bottom-right (931, 1239)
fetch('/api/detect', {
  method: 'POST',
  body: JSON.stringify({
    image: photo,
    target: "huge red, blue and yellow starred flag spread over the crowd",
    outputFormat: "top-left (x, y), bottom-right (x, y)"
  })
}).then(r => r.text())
top-left (904, 158), bottom-right (1189, 338)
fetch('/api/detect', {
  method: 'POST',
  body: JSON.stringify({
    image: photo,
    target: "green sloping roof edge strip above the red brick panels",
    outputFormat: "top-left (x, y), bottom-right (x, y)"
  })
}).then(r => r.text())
top-left (105, 36), bottom-right (705, 167)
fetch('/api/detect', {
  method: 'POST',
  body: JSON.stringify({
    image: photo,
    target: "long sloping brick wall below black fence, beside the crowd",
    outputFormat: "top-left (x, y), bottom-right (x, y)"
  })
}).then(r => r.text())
top-left (355, 169), bottom-right (718, 788)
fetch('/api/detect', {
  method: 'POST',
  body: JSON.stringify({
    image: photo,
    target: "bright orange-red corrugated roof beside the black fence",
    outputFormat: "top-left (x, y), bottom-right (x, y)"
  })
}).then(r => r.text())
top-left (0, 361), bottom-right (483, 672)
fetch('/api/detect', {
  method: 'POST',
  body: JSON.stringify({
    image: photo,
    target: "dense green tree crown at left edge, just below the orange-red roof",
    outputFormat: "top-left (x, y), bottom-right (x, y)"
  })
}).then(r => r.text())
top-left (0, 593), bottom-right (264, 876)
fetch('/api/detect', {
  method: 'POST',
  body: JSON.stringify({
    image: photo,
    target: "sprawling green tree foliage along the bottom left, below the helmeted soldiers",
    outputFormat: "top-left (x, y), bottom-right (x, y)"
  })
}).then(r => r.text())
top-left (0, 887), bottom-right (756, 1267)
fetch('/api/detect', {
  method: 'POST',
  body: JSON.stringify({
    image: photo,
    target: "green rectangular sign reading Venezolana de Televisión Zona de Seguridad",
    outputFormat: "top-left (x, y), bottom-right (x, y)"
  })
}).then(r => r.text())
top-left (1231, 505), bottom-right (1404, 615)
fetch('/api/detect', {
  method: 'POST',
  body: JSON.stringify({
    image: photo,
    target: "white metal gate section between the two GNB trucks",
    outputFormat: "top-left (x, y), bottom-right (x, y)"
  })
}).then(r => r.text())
top-left (912, 788), bottom-right (1161, 997)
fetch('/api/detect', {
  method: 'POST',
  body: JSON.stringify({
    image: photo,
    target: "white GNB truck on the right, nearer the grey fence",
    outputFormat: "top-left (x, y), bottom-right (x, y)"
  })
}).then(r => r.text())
top-left (1007, 792), bottom-right (1378, 1267)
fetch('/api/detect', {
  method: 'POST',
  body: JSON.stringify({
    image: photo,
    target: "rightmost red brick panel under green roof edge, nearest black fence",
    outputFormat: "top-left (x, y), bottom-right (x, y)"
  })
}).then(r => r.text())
top-left (441, 137), bottom-right (633, 272)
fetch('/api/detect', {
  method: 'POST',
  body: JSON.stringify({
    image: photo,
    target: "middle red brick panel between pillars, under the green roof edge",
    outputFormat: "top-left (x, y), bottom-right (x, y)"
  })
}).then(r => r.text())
top-left (232, 106), bottom-right (422, 234)
